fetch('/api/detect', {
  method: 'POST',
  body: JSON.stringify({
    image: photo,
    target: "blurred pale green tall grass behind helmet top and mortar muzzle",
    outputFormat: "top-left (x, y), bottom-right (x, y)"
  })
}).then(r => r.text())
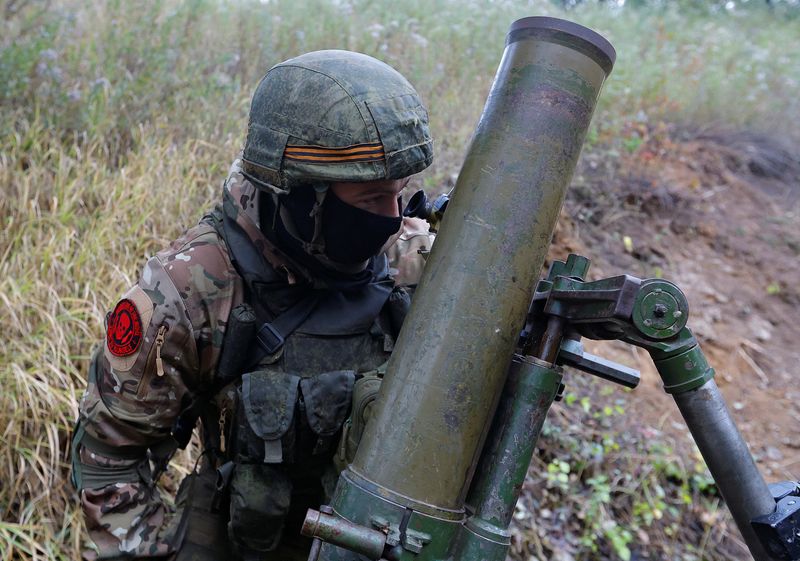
top-left (0, 0), bottom-right (800, 165)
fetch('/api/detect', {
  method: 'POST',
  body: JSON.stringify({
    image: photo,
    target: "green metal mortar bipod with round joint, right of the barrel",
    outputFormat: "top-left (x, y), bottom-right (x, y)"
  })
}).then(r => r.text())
top-left (519, 255), bottom-right (800, 561)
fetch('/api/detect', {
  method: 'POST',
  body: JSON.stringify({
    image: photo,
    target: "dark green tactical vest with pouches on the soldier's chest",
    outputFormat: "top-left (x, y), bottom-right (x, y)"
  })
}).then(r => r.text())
top-left (179, 207), bottom-right (410, 560)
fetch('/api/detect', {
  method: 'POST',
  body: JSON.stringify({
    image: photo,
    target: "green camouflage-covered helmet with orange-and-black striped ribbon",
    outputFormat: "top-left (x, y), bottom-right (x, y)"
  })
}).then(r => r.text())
top-left (242, 50), bottom-right (433, 193)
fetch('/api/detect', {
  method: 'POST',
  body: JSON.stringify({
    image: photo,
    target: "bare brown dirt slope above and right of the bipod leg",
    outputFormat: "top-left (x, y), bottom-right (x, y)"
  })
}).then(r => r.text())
top-left (566, 126), bottom-right (800, 462)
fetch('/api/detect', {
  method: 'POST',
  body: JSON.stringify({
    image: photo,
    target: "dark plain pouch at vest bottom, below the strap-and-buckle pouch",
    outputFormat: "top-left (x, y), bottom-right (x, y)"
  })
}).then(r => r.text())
top-left (228, 464), bottom-right (292, 552)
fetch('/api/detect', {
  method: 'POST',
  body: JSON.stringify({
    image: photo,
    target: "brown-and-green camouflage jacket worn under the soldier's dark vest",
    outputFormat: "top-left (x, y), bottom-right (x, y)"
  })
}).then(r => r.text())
top-left (73, 160), bottom-right (428, 559)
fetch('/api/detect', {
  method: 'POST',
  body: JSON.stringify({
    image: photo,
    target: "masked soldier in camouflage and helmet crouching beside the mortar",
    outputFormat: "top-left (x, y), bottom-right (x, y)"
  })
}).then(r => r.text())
top-left (72, 51), bottom-right (433, 560)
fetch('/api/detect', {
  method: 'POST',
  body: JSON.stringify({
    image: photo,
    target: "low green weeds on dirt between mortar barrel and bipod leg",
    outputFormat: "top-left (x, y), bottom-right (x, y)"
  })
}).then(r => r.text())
top-left (514, 375), bottom-right (737, 561)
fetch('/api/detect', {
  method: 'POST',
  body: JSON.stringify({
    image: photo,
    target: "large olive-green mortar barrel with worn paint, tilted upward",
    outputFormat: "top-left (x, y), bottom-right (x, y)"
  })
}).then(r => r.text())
top-left (350, 17), bottom-right (615, 518)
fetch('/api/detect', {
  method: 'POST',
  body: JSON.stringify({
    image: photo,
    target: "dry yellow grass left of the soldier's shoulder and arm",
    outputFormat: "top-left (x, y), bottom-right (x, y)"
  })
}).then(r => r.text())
top-left (0, 121), bottom-right (236, 559)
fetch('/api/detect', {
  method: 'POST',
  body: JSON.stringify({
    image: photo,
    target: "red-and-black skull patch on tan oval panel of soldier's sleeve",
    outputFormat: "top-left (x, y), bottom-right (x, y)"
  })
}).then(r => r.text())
top-left (105, 286), bottom-right (153, 370)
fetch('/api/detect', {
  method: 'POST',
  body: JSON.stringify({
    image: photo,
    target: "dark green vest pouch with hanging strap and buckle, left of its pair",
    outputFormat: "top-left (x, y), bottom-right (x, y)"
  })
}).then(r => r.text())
top-left (237, 370), bottom-right (300, 464)
